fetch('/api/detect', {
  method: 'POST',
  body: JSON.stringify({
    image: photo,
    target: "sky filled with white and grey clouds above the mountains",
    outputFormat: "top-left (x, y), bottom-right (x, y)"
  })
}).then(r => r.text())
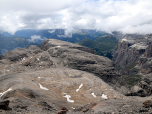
top-left (0, 0), bottom-right (152, 34)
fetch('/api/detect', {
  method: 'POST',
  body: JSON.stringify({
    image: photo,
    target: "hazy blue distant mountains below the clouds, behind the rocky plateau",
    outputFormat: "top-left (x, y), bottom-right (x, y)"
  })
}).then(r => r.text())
top-left (0, 29), bottom-right (108, 55)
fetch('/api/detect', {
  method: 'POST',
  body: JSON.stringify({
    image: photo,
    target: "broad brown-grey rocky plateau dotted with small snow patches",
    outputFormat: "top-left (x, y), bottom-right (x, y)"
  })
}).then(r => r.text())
top-left (0, 39), bottom-right (127, 114)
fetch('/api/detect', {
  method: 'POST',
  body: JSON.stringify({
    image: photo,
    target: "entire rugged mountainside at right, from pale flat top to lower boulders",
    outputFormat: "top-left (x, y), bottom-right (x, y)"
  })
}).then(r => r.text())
top-left (113, 34), bottom-right (152, 96)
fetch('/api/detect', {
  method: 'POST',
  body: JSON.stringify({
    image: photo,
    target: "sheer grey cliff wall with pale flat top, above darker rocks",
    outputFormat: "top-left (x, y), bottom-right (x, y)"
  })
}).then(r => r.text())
top-left (113, 35), bottom-right (152, 68)
